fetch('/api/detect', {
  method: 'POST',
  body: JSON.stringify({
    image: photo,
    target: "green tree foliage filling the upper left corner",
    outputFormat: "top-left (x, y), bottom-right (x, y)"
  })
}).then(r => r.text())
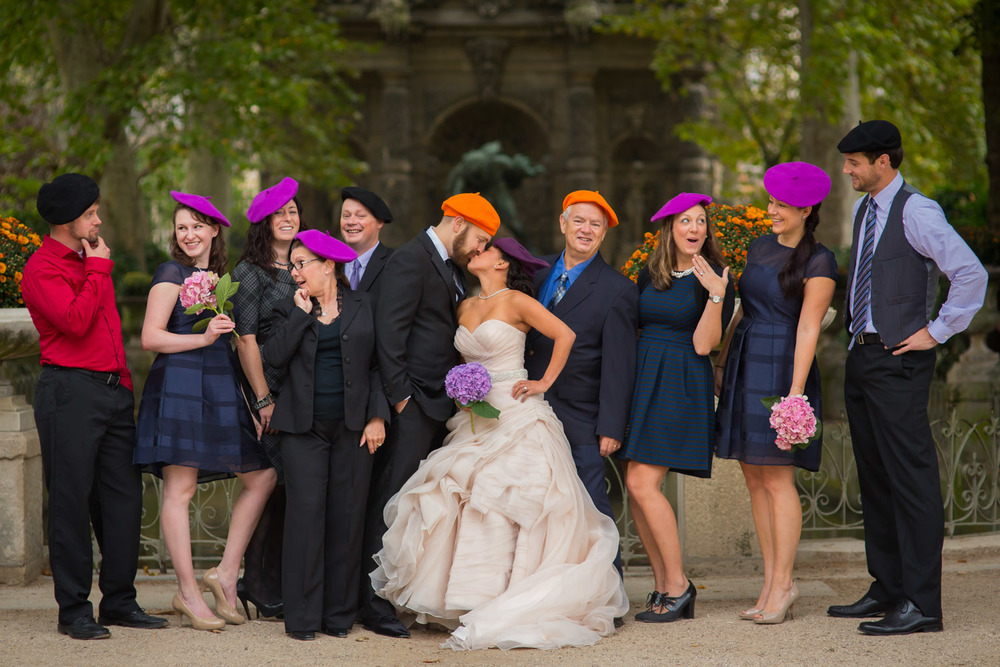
top-left (0, 0), bottom-right (353, 255)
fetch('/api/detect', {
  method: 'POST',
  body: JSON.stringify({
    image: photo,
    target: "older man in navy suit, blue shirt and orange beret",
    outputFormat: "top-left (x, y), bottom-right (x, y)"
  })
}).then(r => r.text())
top-left (525, 190), bottom-right (639, 571)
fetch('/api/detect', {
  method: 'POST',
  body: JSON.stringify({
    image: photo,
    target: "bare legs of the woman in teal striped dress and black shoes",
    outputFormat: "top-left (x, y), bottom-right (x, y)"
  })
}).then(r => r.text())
top-left (625, 461), bottom-right (688, 597)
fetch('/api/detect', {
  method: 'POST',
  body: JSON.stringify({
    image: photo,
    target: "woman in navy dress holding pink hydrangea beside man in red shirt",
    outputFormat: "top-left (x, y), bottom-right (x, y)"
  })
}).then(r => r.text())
top-left (135, 192), bottom-right (275, 630)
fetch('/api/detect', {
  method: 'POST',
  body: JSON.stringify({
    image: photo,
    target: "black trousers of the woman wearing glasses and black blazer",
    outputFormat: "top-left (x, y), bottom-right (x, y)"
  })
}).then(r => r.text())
top-left (281, 419), bottom-right (372, 632)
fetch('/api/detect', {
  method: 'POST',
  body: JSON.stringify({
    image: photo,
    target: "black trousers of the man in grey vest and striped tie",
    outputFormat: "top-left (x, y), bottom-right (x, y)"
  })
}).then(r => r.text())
top-left (844, 345), bottom-right (944, 618)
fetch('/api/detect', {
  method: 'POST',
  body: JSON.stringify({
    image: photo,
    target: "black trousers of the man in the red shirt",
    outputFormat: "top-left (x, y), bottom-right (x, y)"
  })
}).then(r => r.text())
top-left (34, 368), bottom-right (142, 623)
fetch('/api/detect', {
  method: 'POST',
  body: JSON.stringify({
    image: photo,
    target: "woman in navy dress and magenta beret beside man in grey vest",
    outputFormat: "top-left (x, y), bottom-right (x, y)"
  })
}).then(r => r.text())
top-left (716, 162), bottom-right (837, 623)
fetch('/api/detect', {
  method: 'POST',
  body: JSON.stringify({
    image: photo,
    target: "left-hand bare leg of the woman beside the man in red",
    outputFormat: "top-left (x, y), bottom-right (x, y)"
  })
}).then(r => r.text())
top-left (160, 466), bottom-right (215, 618)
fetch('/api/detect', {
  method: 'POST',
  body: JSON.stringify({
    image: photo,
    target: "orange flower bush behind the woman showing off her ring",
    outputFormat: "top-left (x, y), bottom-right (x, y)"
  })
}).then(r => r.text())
top-left (622, 203), bottom-right (771, 285)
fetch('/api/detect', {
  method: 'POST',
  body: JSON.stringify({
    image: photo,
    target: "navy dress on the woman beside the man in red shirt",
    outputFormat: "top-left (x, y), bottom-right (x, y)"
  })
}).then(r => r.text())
top-left (134, 261), bottom-right (270, 481)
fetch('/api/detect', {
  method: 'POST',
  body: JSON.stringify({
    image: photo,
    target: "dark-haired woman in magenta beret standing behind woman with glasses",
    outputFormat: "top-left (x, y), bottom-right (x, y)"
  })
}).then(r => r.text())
top-left (233, 177), bottom-right (309, 618)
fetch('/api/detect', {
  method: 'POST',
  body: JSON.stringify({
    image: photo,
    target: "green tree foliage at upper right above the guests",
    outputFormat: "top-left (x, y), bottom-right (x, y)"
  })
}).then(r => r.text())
top-left (610, 0), bottom-right (985, 196)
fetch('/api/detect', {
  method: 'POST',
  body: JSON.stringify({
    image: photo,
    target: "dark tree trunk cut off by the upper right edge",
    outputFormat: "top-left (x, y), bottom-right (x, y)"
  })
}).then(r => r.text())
top-left (978, 0), bottom-right (1000, 231)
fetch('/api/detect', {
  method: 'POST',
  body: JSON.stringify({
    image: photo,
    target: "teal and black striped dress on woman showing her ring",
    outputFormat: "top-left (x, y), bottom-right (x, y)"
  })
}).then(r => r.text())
top-left (617, 269), bottom-right (734, 477)
